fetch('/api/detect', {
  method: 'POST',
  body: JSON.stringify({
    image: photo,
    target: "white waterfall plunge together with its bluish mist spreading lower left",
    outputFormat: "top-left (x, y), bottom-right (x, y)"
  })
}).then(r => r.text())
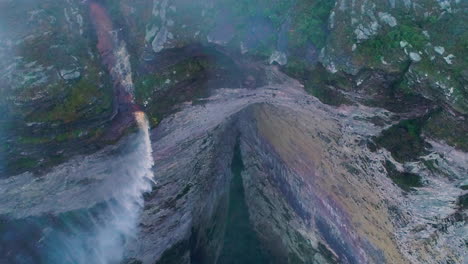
top-left (30, 112), bottom-right (153, 264)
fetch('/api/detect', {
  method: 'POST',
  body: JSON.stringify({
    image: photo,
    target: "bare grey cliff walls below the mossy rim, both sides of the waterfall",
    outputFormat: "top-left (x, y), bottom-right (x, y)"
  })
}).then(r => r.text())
top-left (0, 65), bottom-right (467, 263)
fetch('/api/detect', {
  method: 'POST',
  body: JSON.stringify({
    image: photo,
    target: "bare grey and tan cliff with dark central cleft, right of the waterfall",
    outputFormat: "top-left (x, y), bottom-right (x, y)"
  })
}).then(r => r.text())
top-left (119, 68), bottom-right (466, 263)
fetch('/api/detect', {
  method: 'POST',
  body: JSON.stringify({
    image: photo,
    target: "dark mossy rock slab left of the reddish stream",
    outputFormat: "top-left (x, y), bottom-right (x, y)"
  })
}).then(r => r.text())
top-left (0, 0), bottom-right (113, 178)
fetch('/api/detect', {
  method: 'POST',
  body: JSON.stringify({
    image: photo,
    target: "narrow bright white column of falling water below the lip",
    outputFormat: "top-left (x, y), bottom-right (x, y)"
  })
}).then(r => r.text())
top-left (90, 112), bottom-right (154, 264)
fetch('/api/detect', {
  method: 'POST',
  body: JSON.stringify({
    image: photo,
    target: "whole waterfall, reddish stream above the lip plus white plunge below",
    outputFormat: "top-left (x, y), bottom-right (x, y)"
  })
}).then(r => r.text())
top-left (56, 2), bottom-right (159, 264)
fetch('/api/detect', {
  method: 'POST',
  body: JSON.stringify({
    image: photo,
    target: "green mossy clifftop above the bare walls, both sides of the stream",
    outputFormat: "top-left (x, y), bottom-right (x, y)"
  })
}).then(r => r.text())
top-left (0, 0), bottom-right (467, 175)
